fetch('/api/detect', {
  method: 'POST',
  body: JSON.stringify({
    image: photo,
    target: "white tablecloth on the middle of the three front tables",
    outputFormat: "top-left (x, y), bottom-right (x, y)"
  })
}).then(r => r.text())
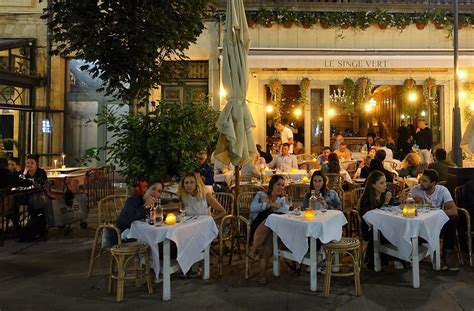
top-left (265, 210), bottom-right (347, 263)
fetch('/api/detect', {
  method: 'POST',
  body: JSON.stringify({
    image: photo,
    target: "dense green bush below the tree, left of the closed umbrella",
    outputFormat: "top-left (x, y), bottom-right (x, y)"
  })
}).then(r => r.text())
top-left (82, 102), bottom-right (217, 184)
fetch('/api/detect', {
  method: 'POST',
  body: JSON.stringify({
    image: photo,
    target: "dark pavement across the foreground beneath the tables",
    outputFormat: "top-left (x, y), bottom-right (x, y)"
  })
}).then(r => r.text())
top-left (0, 216), bottom-right (474, 311)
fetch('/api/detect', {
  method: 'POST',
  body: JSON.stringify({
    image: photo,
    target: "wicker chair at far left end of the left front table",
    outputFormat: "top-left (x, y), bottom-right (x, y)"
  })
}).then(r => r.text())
top-left (88, 195), bottom-right (127, 277)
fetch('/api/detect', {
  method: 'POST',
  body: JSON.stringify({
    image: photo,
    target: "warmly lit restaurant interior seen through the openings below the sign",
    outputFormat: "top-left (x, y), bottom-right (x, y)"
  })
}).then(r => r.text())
top-left (266, 84), bottom-right (443, 154)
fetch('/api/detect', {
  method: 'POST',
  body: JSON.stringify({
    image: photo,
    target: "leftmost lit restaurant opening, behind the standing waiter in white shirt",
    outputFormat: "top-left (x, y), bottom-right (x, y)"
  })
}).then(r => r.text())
top-left (266, 84), bottom-right (308, 154)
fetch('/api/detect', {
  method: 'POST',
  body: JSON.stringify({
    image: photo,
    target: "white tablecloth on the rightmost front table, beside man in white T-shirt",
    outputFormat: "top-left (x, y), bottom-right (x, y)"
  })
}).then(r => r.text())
top-left (364, 209), bottom-right (449, 257)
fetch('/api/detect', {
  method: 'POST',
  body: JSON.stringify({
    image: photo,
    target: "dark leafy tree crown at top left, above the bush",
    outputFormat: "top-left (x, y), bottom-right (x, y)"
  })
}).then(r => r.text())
top-left (43, 0), bottom-right (208, 111)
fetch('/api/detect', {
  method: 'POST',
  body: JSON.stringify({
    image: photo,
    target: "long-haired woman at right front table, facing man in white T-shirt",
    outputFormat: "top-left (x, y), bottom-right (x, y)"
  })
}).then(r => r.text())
top-left (359, 171), bottom-right (394, 269)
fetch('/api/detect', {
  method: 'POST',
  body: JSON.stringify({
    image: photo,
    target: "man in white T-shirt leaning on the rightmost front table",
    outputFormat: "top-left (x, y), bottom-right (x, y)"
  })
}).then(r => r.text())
top-left (410, 169), bottom-right (459, 271)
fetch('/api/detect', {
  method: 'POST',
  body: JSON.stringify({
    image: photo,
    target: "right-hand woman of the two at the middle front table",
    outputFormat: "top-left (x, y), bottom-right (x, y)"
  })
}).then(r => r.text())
top-left (303, 171), bottom-right (342, 210)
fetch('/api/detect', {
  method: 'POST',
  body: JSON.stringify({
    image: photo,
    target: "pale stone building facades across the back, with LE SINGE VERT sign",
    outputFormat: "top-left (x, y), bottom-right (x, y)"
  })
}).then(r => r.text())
top-left (0, 1), bottom-right (474, 165)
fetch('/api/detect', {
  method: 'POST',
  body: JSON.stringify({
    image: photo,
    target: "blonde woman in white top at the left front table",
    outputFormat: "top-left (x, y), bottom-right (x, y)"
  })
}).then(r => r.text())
top-left (178, 173), bottom-right (225, 221)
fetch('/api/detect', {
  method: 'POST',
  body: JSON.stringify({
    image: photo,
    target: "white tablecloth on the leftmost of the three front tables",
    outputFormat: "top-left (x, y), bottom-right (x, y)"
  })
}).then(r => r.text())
top-left (122, 216), bottom-right (218, 278)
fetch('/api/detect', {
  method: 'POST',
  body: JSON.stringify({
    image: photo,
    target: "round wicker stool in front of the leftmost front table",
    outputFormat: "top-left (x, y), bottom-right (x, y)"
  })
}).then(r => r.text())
top-left (109, 242), bottom-right (153, 302)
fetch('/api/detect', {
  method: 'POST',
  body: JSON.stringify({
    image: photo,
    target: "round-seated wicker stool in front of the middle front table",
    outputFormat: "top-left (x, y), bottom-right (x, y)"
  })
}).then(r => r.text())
top-left (323, 238), bottom-right (362, 297)
